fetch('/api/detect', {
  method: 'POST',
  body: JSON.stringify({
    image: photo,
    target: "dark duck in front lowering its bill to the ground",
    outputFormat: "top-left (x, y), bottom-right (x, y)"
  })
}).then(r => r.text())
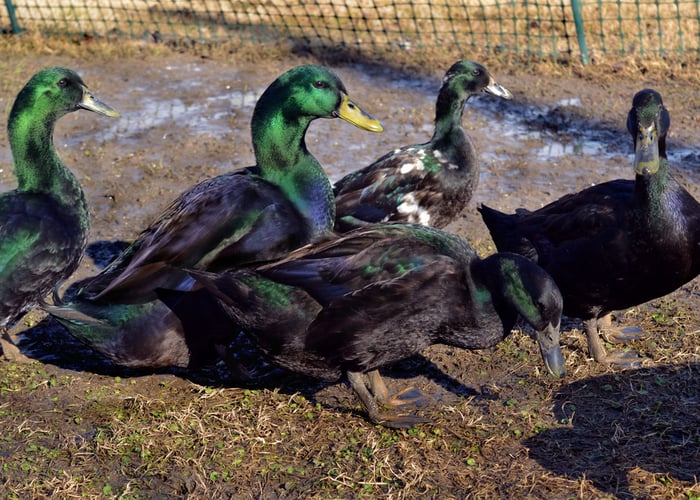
top-left (168, 223), bottom-right (565, 428)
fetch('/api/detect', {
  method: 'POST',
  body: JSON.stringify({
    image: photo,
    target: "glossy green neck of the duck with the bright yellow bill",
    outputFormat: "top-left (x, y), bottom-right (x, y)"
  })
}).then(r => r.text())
top-left (251, 106), bottom-right (335, 237)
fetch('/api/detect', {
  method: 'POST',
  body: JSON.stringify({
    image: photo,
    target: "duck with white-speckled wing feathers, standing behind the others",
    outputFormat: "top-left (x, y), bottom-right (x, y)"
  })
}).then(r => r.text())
top-left (334, 60), bottom-right (513, 232)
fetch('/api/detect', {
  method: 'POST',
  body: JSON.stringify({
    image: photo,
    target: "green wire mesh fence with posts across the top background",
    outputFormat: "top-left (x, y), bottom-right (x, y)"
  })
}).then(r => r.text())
top-left (0, 0), bottom-right (700, 63)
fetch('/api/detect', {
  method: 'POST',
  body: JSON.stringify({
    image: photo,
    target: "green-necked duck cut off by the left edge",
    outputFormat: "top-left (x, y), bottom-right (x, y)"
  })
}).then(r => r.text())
top-left (0, 67), bottom-right (119, 361)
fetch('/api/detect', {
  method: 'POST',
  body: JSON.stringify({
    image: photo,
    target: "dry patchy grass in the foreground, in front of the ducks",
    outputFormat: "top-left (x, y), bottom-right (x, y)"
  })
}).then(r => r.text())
top-left (0, 301), bottom-right (700, 499)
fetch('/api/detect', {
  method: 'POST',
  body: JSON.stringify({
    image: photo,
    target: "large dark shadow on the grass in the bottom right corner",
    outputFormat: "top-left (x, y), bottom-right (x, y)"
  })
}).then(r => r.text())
top-left (525, 363), bottom-right (700, 498)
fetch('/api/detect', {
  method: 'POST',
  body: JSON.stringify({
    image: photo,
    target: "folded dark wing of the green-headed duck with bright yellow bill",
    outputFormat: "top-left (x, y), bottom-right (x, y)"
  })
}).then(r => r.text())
top-left (82, 171), bottom-right (306, 302)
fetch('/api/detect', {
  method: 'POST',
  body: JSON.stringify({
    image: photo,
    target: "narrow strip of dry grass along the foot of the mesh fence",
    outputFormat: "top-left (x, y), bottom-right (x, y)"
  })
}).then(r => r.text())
top-left (0, 21), bottom-right (700, 89)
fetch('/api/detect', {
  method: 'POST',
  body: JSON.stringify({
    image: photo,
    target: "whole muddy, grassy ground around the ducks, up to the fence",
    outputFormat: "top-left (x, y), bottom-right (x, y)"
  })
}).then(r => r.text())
top-left (0, 47), bottom-right (700, 499)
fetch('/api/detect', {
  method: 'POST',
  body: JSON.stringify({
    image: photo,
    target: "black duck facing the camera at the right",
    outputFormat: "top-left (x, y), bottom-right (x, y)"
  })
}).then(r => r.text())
top-left (479, 89), bottom-right (700, 367)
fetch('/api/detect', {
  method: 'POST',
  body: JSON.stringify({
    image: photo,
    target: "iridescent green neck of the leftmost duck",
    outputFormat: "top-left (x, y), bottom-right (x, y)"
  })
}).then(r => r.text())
top-left (8, 106), bottom-right (87, 214)
